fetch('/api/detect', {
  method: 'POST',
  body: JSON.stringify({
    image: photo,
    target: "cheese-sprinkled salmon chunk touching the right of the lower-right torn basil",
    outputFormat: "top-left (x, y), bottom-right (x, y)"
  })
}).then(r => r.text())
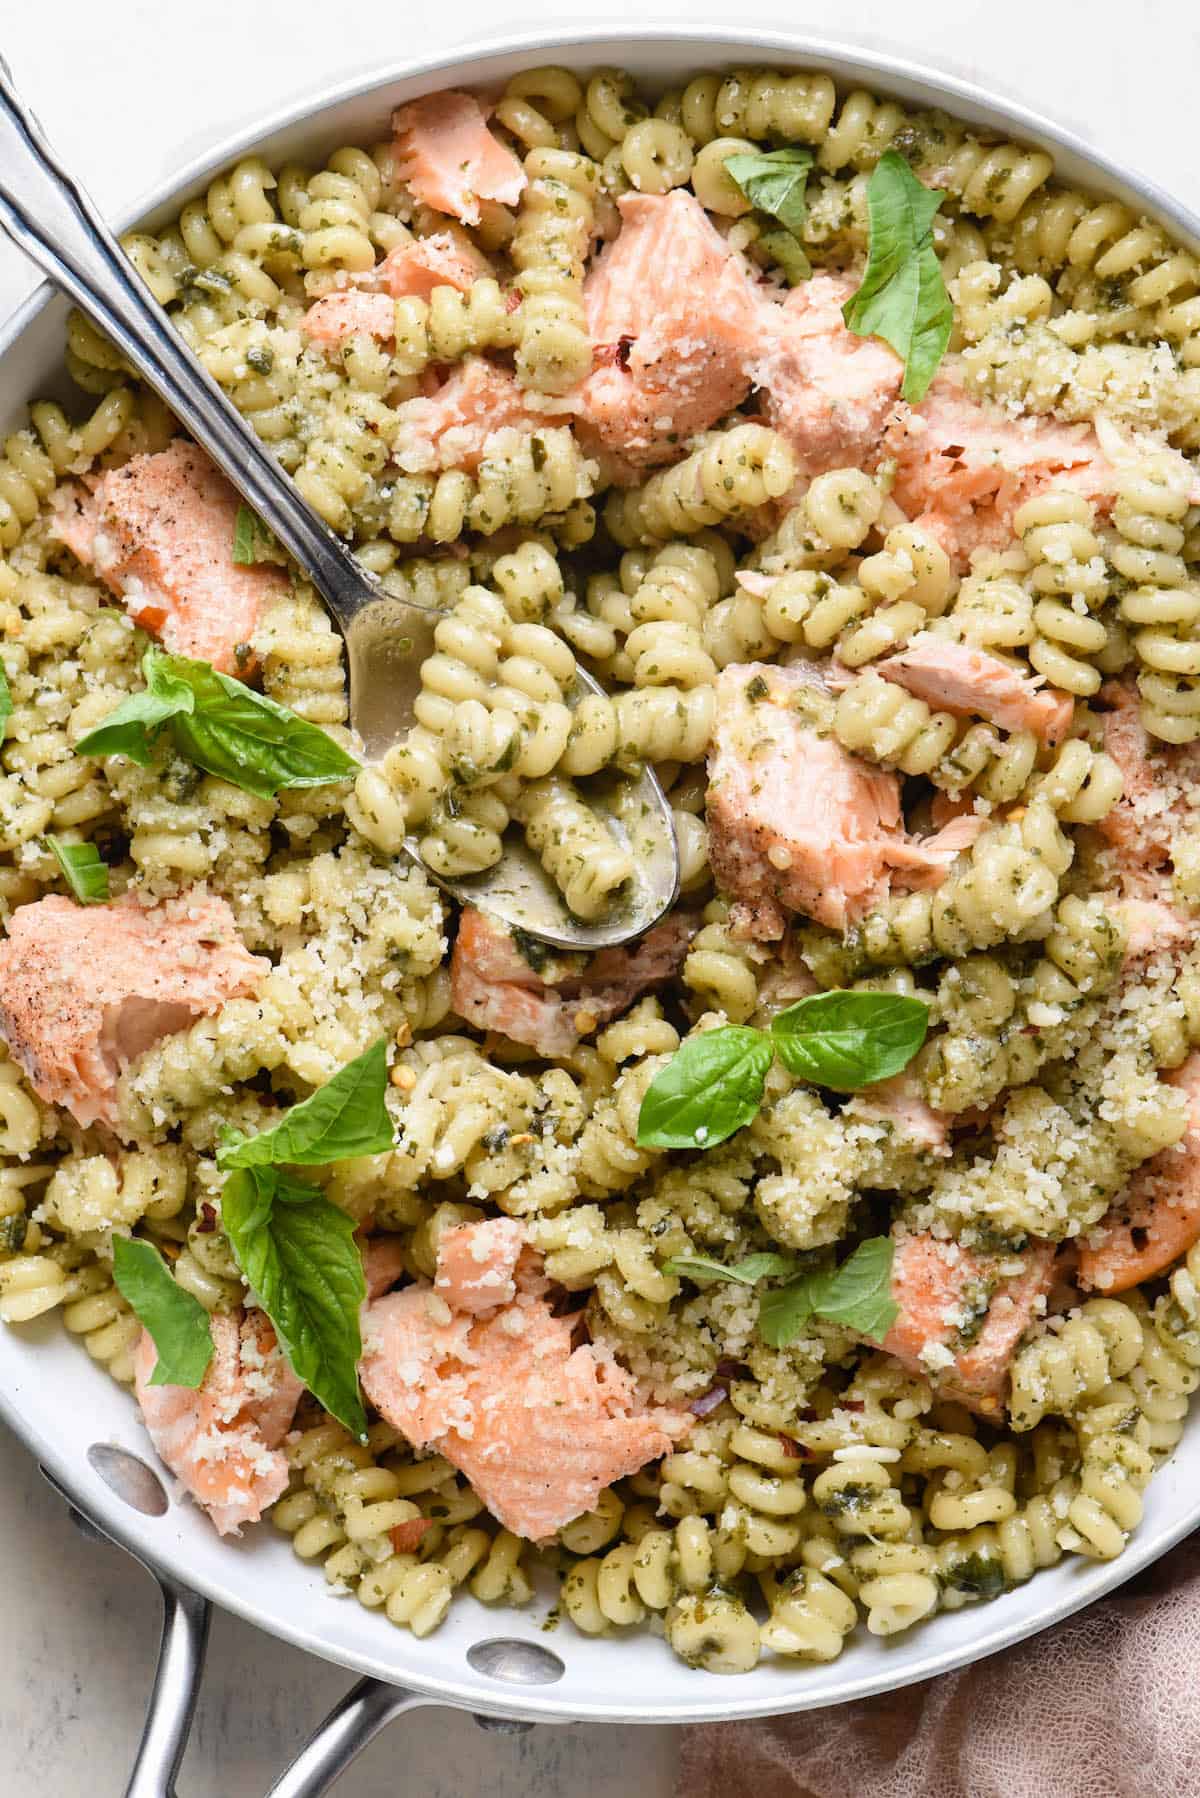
top-left (883, 1224), bottom-right (1054, 1415)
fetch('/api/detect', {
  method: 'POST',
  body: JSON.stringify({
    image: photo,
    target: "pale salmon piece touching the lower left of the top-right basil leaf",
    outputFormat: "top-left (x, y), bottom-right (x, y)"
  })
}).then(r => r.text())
top-left (750, 275), bottom-right (905, 480)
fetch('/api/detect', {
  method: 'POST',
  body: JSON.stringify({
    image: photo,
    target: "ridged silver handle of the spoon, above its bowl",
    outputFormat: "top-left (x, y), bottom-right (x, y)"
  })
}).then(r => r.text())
top-left (0, 56), bottom-right (369, 626)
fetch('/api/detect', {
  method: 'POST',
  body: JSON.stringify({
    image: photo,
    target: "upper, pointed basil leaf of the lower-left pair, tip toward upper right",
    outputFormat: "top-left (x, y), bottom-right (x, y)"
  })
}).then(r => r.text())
top-left (216, 1037), bottom-right (396, 1170)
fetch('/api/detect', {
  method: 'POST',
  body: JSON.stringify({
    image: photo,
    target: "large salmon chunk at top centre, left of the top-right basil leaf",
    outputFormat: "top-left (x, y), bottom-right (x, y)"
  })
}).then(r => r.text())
top-left (572, 187), bottom-right (761, 482)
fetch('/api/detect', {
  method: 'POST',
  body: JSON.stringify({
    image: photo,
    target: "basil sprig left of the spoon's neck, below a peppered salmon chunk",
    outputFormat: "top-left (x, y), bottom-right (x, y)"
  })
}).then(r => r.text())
top-left (76, 645), bottom-right (358, 798)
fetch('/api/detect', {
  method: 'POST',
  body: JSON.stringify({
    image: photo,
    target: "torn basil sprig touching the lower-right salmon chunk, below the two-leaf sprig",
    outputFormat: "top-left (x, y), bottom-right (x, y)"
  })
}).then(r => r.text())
top-left (662, 1237), bottom-right (900, 1349)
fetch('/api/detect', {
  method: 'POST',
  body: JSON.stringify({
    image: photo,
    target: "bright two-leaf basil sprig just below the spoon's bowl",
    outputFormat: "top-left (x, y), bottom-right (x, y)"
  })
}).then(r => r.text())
top-left (637, 991), bottom-right (928, 1149)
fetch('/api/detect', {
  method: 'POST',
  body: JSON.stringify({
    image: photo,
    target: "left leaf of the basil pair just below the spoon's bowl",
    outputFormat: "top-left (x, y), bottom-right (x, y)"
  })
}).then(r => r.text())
top-left (637, 1023), bottom-right (774, 1149)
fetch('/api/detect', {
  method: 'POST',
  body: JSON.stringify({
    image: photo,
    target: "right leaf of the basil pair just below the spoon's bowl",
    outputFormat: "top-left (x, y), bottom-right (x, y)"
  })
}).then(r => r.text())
top-left (770, 991), bottom-right (928, 1093)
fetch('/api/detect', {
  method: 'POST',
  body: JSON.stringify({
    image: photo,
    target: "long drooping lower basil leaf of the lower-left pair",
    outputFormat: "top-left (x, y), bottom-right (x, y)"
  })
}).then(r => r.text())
top-left (221, 1167), bottom-right (367, 1440)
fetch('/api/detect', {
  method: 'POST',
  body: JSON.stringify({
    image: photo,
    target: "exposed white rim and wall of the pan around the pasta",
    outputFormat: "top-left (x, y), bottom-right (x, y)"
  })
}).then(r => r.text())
top-left (0, 29), bottom-right (1200, 1722)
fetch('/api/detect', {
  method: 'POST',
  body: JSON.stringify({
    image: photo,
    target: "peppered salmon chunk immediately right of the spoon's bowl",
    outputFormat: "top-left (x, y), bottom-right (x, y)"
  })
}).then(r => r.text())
top-left (707, 662), bottom-right (957, 940)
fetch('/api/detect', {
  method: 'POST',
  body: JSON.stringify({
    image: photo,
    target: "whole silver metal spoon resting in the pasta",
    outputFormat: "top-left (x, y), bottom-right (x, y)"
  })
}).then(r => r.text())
top-left (0, 58), bottom-right (678, 949)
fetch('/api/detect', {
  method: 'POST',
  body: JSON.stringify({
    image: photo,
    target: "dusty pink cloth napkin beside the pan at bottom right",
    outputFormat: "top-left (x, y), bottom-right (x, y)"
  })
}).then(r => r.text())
top-left (678, 1535), bottom-right (1200, 1798)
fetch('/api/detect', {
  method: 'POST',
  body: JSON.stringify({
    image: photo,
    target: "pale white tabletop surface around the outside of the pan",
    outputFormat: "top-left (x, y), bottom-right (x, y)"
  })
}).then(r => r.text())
top-left (0, 0), bottom-right (1200, 1798)
